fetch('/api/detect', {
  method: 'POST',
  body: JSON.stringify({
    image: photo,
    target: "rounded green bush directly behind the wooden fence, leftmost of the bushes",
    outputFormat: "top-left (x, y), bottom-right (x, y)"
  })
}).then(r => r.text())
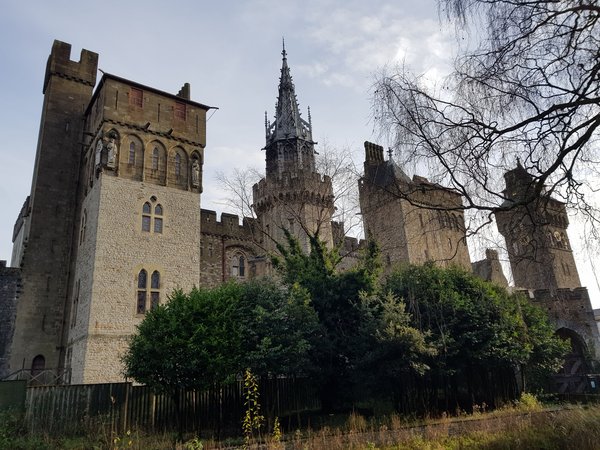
top-left (124, 280), bottom-right (316, 392)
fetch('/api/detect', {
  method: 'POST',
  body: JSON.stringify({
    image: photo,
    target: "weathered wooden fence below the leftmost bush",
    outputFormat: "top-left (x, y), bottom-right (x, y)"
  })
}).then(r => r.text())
top-left (25, 379), bottom-right (320, 436)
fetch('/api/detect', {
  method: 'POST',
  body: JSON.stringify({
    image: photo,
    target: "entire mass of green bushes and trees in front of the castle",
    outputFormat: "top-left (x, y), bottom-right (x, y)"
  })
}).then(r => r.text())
top-left (124, 232), bottom-right (569, 425)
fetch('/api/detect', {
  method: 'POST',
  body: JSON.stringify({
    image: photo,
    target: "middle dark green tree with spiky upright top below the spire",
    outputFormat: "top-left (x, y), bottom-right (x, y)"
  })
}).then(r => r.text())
top-left (273, 231), bottom-right (434, 410)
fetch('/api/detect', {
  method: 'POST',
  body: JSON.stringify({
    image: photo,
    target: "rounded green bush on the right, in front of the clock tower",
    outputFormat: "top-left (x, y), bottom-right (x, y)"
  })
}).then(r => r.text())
top-left (385, 264), bottom-right (568, 400)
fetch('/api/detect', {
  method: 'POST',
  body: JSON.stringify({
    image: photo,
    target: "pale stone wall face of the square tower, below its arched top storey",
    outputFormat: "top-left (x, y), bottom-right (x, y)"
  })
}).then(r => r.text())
top-left (70, 176), bottom-right (200, 383)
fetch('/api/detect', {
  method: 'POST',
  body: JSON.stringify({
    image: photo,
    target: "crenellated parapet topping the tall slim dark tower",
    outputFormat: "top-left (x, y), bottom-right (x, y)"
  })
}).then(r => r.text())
top-left (43, 40), bottom-right (98, 94)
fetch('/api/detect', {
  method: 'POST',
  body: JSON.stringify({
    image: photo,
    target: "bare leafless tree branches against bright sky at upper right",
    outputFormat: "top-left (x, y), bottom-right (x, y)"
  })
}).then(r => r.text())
top-left (374, 0), bottom-right (600, 232)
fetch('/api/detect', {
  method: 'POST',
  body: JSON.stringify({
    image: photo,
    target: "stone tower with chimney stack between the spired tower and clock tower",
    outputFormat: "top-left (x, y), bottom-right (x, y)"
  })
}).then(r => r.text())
top-left (359, 142), bottom-right (471, 270)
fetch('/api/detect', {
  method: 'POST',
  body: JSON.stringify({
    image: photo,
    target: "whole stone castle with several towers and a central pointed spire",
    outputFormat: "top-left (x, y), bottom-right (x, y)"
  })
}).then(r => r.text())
top-left (0, 41), bottom-right (600, 390)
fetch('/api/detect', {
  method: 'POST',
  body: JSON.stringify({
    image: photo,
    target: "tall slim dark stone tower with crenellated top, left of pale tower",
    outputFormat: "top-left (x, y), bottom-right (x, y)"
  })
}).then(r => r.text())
top-left (9, 41), bottom-right (98, 378)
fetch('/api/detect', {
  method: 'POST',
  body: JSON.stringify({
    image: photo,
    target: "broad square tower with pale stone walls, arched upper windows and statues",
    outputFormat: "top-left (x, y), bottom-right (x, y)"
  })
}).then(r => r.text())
top-left (64, 74), bottom-right (209, 383)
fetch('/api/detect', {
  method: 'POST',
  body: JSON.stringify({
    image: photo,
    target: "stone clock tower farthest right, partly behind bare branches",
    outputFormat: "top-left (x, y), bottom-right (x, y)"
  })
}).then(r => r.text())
top-left (496, 163), bottom-right (581, 290)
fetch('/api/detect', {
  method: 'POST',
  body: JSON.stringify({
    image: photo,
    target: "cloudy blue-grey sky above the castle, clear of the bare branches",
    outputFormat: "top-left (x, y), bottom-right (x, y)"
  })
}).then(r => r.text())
top-left (0, 0), bottom-right (600, 307)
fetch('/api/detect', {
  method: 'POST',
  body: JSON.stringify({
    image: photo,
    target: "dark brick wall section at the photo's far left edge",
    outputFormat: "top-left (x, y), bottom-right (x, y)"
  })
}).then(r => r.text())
top-left (0, 261), bottom-right (21, 380)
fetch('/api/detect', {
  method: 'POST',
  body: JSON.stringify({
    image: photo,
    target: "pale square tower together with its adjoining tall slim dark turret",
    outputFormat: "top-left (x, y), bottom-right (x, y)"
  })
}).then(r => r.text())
top-left (10, 41), bottom-right (210, 383)
